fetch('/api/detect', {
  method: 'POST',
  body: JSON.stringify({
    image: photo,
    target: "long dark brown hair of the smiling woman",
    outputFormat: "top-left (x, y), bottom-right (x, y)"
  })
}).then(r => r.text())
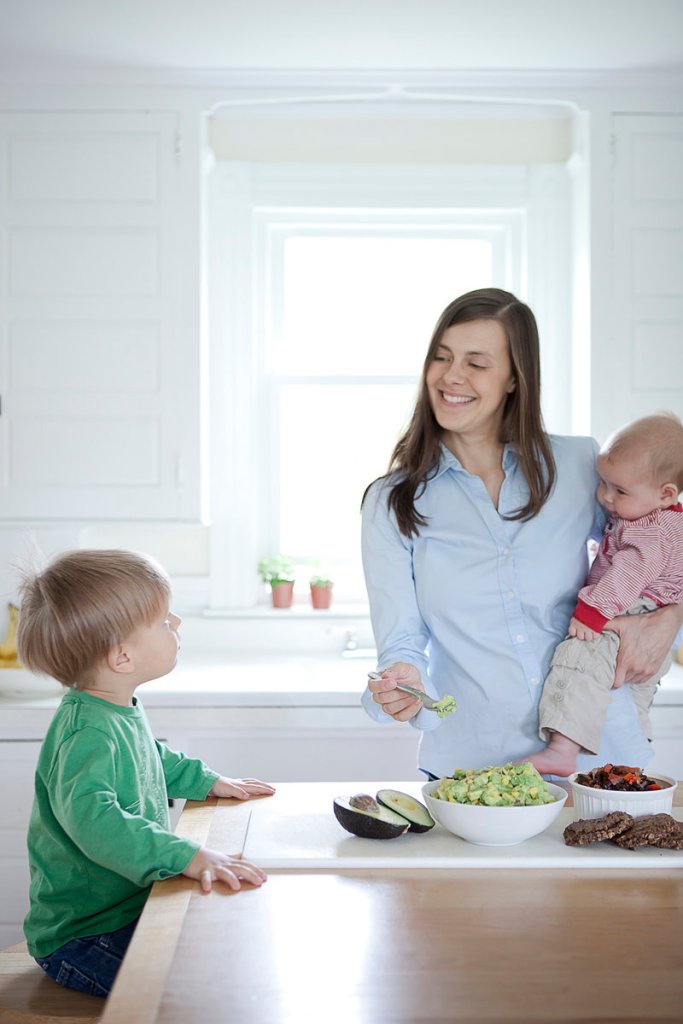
top-left (370, 288), bottom-right (555, 537)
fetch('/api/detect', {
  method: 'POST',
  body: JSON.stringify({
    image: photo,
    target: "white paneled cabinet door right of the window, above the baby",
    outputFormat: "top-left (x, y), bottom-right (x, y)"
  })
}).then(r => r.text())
top-left (600, 114), bottom-right (683, 431)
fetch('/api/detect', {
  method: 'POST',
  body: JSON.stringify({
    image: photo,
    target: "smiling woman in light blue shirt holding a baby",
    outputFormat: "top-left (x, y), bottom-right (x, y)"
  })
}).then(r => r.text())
top-left (362, 288), bottom-right (683, 776)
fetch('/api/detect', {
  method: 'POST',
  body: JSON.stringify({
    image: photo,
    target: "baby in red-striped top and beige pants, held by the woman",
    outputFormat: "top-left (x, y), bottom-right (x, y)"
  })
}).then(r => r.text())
top-left (528, 414), bottom-right (683, 776)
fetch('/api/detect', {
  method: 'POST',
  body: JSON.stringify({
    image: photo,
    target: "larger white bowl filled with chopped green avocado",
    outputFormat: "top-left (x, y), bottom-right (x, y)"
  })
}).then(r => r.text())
top-left (422, 780), bottom-right (567, 846)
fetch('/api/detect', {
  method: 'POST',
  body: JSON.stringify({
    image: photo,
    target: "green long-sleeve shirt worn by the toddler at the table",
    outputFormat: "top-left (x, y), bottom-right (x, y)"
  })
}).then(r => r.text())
top-left (24, 690), bottom-right (218, 956)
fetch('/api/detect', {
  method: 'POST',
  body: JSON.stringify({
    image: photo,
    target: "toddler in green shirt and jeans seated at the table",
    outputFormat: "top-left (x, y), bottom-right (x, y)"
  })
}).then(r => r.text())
top-left (17, 551), bottom-right (274, 996)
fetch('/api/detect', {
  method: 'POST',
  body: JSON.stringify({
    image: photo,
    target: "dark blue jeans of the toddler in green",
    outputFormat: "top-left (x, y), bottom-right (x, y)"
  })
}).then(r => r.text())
top-left (36, 918), bottom-right (139, 998)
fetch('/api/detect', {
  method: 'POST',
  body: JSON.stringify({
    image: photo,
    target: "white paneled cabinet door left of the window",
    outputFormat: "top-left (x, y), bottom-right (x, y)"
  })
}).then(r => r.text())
top-left (0, 111), bottom-right (200, 520)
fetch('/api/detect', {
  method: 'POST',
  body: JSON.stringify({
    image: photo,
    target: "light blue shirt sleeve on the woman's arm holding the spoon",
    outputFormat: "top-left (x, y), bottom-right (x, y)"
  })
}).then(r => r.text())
top-left (361, 480), bottom-right (440, 730)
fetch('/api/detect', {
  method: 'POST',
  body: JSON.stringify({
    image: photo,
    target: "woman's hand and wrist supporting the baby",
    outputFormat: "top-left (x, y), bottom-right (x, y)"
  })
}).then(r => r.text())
top-left (605, 604), bottom-right (683, 689)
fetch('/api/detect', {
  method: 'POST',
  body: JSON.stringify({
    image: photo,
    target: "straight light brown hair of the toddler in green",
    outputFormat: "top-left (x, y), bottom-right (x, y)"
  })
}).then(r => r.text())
top-left (17, 550), bottom-right (171, 689)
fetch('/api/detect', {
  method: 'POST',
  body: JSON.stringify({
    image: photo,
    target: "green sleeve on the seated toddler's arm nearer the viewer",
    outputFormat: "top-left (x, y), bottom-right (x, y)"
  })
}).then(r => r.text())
top-left (48, 729), bottom-right (199, 887)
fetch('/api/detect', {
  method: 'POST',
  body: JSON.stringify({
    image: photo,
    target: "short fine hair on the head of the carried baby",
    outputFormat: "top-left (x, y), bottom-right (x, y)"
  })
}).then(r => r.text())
top-left (601, 412), bottom-right (683, 494)
